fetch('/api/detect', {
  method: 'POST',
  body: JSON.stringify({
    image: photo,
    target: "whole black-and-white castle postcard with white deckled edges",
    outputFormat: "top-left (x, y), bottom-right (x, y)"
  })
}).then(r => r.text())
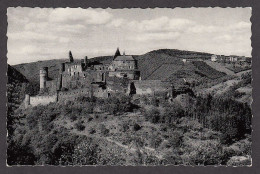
top-left (6, 7), bottom-right (253, 167)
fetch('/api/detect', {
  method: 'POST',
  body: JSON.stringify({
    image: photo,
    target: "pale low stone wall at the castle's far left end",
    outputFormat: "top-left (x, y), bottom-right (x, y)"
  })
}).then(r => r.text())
top-left (30, 95), bottom-right (57, 106)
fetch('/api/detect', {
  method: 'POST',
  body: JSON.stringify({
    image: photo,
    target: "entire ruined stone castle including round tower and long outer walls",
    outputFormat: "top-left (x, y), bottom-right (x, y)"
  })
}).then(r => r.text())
top-left (25, 49), bottom-right (173, 106)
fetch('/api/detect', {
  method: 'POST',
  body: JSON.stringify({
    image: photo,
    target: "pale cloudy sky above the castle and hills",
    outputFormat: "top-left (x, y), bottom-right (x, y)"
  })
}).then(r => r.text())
top-left (7, 7), bottom-right (251, 65)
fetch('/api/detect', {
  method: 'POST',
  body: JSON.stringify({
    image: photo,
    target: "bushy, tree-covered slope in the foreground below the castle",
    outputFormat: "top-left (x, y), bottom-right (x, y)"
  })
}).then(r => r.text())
top-left (7, 90), bottom-right (251, 165)
